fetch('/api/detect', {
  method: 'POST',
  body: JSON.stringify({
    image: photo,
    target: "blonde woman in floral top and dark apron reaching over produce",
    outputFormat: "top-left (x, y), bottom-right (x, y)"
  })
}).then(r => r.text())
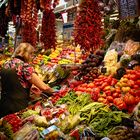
top-left (0, 43), bottom-right (53, 118)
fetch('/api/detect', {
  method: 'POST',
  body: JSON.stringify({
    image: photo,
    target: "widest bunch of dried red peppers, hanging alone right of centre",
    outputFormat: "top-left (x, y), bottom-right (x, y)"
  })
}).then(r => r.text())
top-left (74, 0), bottom-right (103, 51)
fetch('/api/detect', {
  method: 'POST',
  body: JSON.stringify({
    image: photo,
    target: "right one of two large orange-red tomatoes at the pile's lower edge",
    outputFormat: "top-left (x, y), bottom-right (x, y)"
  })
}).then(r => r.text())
top-left (124, 93), bottom-right (135, 105)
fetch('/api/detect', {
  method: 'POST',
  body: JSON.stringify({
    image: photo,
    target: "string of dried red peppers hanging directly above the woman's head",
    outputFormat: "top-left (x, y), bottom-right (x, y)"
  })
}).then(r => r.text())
top-left (21, 0), bottom-right (38, 46)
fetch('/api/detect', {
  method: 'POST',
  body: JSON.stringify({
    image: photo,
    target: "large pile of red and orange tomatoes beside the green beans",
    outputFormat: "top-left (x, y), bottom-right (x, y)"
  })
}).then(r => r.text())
top-left (74, 70), bottom-right (140, 112)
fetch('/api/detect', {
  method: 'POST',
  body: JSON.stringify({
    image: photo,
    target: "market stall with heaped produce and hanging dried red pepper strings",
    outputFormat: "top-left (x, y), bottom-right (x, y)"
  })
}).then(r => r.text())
top-left (0, 0), bottom-right (140, 140)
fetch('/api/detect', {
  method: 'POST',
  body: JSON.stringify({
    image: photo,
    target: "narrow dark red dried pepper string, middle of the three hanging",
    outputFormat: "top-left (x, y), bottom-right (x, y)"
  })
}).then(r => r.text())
top-left (40, 0), bottom-right (59, 49)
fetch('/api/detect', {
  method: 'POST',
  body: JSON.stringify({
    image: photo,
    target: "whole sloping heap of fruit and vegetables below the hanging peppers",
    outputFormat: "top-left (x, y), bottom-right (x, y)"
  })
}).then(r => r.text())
top-left (0, 41), bottom-right (140, 140)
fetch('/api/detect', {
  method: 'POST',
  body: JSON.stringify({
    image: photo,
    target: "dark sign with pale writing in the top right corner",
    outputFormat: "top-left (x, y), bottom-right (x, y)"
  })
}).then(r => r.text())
top-left (118, 0), bottom-right (139, 19)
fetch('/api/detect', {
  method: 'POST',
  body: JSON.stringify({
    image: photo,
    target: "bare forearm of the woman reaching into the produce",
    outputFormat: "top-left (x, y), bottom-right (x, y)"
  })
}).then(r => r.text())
top-left (29, 73), bottom-right (54, 93)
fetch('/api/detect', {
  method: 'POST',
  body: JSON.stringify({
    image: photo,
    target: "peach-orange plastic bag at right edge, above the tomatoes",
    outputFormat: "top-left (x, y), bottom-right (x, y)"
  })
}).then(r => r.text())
top-left (124, 40), bottom-right (140, 56)
